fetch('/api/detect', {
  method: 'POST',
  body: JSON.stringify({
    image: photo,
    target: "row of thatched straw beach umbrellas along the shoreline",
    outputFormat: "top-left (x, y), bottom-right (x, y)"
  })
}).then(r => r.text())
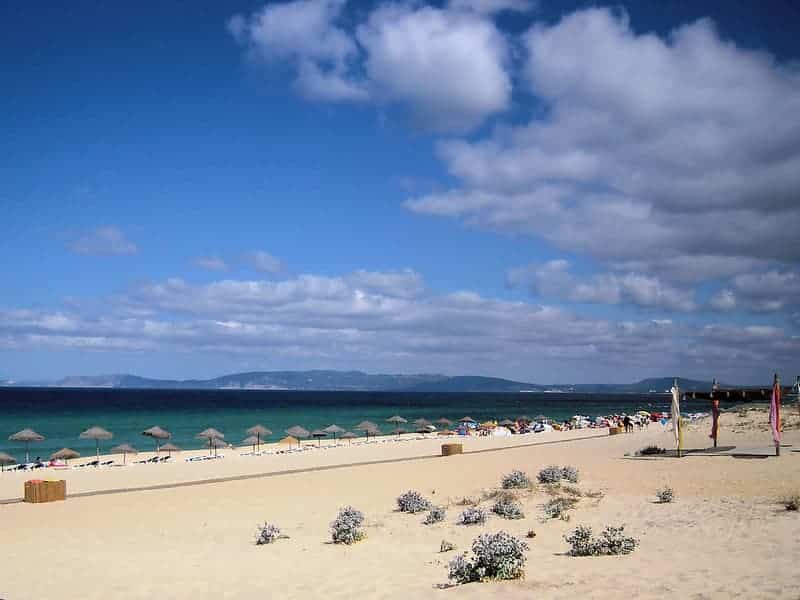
top-left (0, 415), bottom-right (531, 468)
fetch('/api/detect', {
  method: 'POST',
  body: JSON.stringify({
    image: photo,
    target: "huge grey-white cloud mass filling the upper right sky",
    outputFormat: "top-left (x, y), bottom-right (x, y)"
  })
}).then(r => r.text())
top-left (406, 9), bottom-right (800, 282)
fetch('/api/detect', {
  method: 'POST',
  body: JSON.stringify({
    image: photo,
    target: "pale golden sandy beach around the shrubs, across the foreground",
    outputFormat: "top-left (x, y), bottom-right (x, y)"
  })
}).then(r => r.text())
top-left (0, 406), bottom-right (800, 600)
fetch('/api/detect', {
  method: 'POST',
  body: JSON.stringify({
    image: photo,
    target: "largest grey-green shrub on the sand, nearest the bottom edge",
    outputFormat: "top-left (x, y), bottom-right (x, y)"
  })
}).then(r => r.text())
top-left (448, 531), bottom-right (528, 583)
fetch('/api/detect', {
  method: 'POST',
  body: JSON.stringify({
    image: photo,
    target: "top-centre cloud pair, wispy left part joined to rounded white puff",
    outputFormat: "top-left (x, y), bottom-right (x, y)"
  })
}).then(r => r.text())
top-left (228, 0), bottom-right (510, 131)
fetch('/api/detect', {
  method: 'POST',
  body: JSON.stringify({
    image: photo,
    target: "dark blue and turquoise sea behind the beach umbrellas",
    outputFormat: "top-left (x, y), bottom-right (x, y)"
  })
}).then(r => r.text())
top-left (0, 387), bottom-right (708, 460)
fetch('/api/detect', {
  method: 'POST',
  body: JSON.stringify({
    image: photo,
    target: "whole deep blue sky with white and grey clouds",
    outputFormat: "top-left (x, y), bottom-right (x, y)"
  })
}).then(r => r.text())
top-left (0, 0), bottom-right (800, 384)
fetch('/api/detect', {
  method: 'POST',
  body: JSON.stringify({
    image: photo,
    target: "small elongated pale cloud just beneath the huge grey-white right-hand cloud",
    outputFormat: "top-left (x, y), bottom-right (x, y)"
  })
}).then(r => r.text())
top-left (508, 260), bottom-right (696, 311)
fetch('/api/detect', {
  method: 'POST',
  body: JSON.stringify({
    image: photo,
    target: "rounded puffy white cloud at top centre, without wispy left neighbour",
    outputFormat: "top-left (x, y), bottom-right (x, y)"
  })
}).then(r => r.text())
top-left (358, 4), bottom-right (511, 130)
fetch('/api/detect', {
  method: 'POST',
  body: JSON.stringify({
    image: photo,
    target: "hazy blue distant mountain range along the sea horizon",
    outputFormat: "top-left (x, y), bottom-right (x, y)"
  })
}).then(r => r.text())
top-left (0, 370), bottom-right (711, 394)
